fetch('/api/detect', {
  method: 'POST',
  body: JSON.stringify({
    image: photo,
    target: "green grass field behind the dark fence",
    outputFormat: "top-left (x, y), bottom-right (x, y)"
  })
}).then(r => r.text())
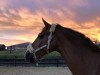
top-left (0, 49), bottom-right (61, 59)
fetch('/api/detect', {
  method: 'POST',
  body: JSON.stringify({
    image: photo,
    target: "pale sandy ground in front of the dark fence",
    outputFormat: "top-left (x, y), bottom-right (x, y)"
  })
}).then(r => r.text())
top-left (0, 67), bottom-right (72, 75)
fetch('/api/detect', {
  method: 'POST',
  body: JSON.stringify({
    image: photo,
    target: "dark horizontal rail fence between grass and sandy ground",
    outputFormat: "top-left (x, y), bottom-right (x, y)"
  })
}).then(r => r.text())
top-left (0, 59), bottom-right (66, 67)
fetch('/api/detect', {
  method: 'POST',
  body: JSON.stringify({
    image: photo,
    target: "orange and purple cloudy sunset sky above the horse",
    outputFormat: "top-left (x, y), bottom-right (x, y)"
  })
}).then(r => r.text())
top-left (0, 0), bottom-right (100, 46)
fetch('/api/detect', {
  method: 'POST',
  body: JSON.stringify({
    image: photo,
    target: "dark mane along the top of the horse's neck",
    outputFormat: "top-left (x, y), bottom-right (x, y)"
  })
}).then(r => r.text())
top-left (58, 25), bottom-right (100, 52)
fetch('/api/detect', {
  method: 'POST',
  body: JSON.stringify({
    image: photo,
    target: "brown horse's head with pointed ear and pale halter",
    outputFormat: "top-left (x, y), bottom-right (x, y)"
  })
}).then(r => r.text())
top-left (25, 19), bottom-right (58, 63)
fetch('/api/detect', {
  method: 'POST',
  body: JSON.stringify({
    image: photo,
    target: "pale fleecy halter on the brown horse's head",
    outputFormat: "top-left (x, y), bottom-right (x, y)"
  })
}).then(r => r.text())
top-left (27, 23), bottom-right (57, 66)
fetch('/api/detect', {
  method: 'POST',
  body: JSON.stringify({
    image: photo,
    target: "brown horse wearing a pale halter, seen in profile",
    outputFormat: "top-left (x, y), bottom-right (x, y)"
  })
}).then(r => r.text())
top-left (25, 19), bottom-right (100, 75)
